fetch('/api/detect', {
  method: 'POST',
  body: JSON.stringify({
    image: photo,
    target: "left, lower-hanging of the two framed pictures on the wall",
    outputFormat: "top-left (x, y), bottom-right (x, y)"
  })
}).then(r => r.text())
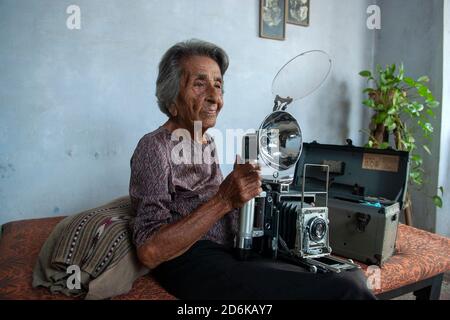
top-left (259, 0), bottom-right (286, 40)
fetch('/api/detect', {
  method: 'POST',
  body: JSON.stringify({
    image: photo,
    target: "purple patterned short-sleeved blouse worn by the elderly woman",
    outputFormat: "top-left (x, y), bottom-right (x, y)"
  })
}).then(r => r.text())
top-left (129, 127), bottom-right (238, 246)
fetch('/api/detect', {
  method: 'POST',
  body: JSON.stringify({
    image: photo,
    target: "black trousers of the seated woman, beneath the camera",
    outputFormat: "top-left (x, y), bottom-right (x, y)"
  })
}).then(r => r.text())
top-left (152, 240), bottom-right (375, 300)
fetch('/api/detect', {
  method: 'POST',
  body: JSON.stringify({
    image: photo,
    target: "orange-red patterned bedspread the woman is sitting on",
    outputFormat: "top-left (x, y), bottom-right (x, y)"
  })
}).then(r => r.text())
top-left (0, 217), bottom-right (450, 300)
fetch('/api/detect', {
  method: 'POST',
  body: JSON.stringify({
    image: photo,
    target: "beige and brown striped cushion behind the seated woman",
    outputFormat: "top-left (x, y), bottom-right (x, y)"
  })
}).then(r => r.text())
top-left (33, 196), bottom-right (148, 299)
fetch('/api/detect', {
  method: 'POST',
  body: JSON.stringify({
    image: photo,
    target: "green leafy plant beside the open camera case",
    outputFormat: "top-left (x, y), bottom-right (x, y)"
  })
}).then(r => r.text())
top-left (359, 64), bottom-right (443, 225)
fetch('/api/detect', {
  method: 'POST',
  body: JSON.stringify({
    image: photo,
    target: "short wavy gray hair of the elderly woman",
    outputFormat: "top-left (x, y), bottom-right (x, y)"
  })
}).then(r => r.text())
top-left (156, 39), bottom-right (228, 117)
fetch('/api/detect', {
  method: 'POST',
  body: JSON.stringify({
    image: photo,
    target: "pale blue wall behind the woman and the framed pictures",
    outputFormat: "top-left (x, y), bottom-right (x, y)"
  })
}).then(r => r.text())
top-left (0, 0), bottom-right (374, 224)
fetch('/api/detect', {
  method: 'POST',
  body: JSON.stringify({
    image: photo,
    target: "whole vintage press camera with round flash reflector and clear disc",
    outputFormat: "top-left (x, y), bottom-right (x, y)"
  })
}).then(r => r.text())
top-left (236, 51), bottom-right (359, 272)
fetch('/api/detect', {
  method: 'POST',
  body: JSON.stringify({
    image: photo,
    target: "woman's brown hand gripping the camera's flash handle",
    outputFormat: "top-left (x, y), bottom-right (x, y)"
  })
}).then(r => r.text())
top-left (217, 156), bottom-right (263, 210)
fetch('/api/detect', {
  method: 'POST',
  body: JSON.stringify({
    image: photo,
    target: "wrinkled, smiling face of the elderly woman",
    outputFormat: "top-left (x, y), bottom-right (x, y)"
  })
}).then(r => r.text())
top-left (169, 56), bottom-right (223, 131)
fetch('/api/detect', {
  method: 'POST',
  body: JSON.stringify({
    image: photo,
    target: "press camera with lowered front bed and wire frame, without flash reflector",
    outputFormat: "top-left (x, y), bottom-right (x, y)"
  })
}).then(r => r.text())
top-left (235, 134), bottom-right (359, 272)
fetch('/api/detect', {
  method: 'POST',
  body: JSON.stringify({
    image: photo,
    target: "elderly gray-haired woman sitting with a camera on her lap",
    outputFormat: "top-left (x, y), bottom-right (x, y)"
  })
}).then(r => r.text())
top-left (130, 40), bottom-right (374, 299)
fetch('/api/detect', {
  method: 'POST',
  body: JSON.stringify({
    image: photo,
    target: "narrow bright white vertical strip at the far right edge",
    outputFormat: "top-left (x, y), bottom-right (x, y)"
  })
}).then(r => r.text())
top-left (436, 1), bottom-right (450, 237)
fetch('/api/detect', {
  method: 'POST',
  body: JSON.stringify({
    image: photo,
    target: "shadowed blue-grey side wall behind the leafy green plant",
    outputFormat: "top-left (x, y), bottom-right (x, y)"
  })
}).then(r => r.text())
top-left (374, 0), bottom-right (444, 231)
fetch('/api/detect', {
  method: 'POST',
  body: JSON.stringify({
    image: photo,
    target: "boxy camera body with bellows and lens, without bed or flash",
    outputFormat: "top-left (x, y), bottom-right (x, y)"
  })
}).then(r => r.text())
top-left (238, 182), bottom-right (331, 260)
